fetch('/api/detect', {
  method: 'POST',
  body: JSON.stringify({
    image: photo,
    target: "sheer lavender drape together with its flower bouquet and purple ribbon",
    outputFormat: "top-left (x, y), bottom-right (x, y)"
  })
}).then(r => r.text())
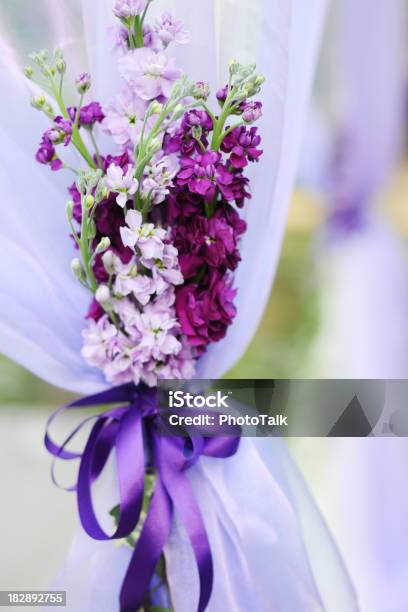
top-left (0, 0), bottom-right (357, 612)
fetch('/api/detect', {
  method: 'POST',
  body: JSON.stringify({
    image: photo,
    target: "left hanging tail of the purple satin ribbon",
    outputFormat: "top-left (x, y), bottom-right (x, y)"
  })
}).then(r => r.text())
top-left (120, 478), bottom-right (172, 612)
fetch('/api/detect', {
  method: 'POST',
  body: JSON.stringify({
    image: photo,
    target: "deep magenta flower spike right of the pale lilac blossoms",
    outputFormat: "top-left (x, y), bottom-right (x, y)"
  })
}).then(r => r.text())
top-left (159, 106), bottom-right (262, 353)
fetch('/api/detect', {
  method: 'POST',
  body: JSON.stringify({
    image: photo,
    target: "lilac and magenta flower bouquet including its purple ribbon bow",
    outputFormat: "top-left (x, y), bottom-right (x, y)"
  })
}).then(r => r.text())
top-left (25, 0), bottom-right (264, 611)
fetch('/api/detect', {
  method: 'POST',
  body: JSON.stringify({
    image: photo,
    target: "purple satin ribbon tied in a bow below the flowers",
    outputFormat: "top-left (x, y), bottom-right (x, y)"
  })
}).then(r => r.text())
top-left (45, 384), bottom-right (239, 612)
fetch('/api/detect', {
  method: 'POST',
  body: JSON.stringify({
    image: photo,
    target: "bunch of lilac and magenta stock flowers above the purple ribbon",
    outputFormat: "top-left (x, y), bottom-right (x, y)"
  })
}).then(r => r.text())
top-left (30, 2), bottom-right (264, 387)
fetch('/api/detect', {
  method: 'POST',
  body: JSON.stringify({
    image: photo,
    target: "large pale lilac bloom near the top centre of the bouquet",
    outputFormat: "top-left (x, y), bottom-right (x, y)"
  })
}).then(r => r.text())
top-left (119, 48), bottom-right (181, 100)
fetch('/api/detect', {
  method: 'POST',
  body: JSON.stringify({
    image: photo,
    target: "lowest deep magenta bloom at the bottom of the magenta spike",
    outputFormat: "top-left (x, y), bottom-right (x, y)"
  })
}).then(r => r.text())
top-left (176, 272), bottom-right (236, 353)
